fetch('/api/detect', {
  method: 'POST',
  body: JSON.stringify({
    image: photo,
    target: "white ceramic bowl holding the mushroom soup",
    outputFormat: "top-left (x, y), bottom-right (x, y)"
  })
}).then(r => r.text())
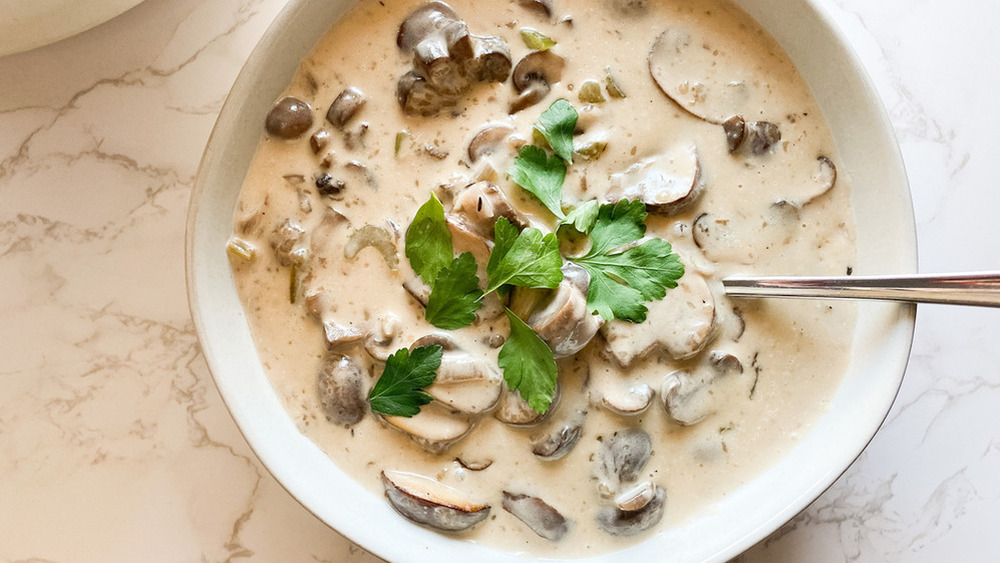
top-left (187, 0), bottom-right (916, 563)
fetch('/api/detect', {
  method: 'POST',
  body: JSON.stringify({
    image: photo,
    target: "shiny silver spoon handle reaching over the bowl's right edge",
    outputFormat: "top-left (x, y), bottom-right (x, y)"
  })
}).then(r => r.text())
top-left (722, 271), bottom-right (1000, 307)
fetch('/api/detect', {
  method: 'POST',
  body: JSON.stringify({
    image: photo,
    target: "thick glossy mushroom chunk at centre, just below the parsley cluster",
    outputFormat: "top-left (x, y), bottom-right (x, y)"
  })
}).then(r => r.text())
top-left (511, 261), bottom-right (604, 358)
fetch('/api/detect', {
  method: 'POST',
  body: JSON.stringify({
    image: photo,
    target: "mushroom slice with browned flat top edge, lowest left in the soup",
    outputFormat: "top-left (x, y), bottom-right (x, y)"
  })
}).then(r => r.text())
top-left (382, 470), bottom-right (490, 532)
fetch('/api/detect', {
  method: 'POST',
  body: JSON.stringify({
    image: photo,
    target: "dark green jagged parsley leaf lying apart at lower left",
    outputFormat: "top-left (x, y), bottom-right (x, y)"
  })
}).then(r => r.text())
top-left (368, 346), bottom-right (444, 417)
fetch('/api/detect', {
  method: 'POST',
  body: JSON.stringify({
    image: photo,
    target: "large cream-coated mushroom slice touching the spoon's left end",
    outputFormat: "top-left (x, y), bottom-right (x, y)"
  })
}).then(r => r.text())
top-left (601, 269), bottom-right (716, 367)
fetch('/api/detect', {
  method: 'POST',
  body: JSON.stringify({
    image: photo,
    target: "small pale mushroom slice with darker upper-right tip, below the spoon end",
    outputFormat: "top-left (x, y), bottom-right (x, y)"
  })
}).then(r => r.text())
top-left (660, 352), bottom-right (743, 426)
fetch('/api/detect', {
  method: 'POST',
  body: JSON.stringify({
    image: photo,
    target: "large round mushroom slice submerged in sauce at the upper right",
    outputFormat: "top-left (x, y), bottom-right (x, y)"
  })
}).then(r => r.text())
top-left (648, 26), bottom-right (754, 124)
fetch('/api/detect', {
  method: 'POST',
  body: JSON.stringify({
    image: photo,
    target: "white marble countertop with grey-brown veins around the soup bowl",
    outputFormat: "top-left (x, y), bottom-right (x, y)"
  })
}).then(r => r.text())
top-left (0, 0), bottom-right (1000, 563)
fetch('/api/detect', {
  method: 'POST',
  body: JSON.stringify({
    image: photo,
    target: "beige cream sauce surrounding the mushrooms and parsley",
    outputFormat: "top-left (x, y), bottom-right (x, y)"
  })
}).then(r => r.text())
top-left (233, 0), bottom-right (854, 556)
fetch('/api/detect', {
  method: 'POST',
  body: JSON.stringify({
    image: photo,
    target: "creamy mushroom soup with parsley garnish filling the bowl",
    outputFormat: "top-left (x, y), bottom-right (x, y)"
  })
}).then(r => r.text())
top-left (228, 0), bottom-right (854, 556)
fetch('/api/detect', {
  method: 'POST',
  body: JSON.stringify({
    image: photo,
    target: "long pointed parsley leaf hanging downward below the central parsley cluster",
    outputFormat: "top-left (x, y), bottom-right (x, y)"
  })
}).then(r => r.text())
top-left (498, 309), bottom-right (559, 414)
